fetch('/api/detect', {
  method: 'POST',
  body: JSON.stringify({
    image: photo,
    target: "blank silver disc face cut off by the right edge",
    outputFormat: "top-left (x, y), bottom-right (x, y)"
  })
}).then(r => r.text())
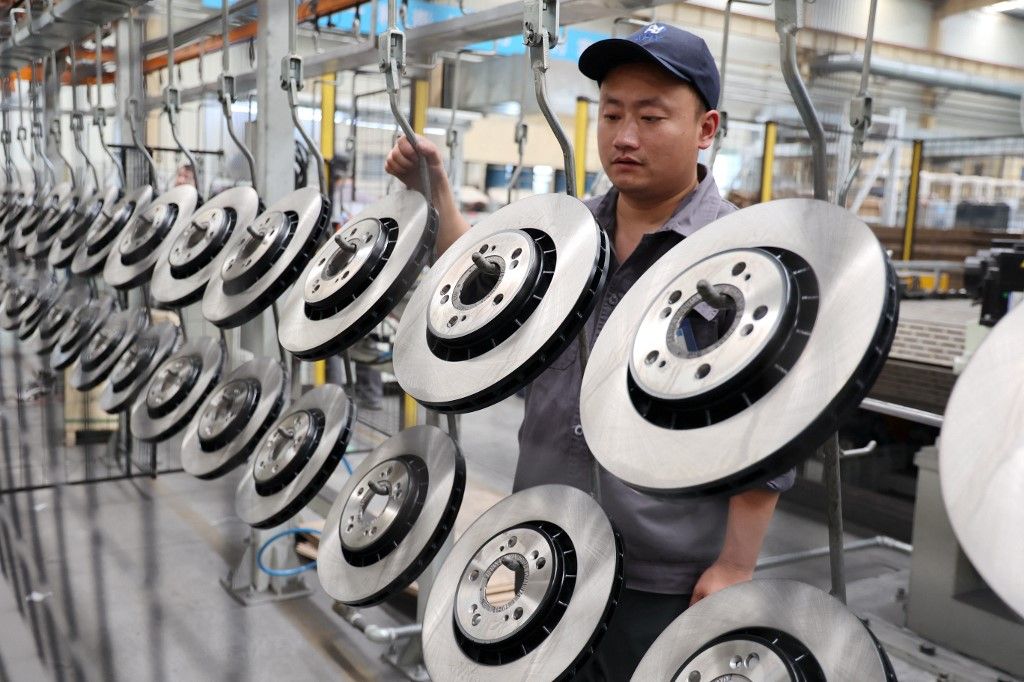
top-left (939, 305), bottom-right (1024, 617)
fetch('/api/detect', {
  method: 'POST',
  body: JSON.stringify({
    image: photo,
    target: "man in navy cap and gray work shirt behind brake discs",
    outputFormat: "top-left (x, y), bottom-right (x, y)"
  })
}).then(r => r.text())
top-left (385, 23), bottom-right (795, 681)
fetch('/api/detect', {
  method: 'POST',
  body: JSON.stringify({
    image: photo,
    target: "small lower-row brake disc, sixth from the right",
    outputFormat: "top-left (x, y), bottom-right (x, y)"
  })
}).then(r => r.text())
top-left (131, 336), bottom-right (224, 442)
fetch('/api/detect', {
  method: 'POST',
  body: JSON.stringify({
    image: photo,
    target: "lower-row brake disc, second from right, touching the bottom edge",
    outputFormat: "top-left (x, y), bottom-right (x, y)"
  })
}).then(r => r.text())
top-left (423, 485), bottom-right (623, 680)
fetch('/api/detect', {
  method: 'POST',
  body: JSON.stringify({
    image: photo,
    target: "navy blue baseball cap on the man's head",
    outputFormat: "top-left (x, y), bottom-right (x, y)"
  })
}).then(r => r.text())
top-left (580, 23), bottom-right (722, 109)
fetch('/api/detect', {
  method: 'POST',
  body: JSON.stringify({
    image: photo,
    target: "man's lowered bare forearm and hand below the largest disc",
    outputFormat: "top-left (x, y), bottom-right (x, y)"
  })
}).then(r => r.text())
top-left (690, 489), bottom-right (779, 606)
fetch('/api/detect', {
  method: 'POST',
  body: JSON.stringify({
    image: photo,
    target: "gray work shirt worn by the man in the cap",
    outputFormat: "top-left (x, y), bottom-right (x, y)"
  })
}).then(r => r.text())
top-left (513, 166), bottom-right (795, 594)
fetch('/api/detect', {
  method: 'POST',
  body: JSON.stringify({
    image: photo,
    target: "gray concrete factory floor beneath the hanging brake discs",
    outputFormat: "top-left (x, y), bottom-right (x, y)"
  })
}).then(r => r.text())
top-left (0, 391), bottom-right (1011, 682)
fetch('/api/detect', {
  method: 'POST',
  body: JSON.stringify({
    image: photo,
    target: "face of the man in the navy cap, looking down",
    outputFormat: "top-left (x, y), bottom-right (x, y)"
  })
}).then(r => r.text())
top-left (597, 63), bottom-right (719, 200)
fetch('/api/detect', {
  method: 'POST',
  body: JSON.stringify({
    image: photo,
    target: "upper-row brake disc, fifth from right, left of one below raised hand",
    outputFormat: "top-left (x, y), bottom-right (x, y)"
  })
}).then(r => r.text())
top-left (203, 187), bottom-right (331, 328)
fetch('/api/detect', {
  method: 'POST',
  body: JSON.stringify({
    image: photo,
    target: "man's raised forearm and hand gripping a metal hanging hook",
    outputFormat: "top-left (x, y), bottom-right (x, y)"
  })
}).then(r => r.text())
top-left (384, 136), bottom-right (469, 256)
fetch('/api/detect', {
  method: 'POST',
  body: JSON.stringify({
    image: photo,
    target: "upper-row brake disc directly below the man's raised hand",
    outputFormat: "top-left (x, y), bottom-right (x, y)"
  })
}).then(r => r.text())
top-left (278, 189), bottom-right (437, 359)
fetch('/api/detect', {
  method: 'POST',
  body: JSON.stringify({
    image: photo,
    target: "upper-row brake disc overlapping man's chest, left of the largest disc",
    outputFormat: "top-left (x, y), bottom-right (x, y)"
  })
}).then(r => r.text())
top-left (394, 195), bottom-right (610, 412)
